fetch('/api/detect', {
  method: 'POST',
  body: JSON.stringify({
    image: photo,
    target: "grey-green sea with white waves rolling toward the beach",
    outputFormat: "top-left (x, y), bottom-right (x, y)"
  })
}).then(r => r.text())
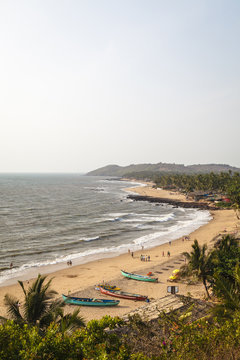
top-left (0, 174), bottom-right (211, 286)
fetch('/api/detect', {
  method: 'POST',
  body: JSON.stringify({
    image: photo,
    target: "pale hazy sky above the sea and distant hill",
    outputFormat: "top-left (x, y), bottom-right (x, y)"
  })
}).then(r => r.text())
top-left (0, 0), bottom-right (240, 172)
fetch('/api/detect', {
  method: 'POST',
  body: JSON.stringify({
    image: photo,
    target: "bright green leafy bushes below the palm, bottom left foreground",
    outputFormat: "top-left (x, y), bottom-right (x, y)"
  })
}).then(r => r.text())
top-left (0, 316), bottom-right (130, 360)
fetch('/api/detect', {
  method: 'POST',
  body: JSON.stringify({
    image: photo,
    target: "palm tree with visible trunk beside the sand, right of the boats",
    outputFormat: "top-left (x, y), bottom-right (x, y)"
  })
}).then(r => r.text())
top-left (183, 240), bottom-right (213, 298)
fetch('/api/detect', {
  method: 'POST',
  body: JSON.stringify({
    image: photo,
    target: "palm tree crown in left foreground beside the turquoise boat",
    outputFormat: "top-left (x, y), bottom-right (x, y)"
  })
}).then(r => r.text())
top-left (1, 274), bottom-right (84, 329)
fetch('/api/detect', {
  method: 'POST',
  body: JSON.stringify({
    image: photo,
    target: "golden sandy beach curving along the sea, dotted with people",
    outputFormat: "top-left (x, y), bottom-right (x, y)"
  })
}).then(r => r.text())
top-left (0, 185), bottom-right (240, 321)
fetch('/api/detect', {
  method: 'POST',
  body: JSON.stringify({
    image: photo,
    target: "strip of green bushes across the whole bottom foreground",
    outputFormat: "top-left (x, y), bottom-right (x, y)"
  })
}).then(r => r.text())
top-left (0, 308), bottom-right (240, 360)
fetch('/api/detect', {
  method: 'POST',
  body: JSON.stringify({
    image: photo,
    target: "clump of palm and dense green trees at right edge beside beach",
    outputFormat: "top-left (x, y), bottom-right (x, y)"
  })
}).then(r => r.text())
top-left (181, 235), bottom-right (240, 321)
